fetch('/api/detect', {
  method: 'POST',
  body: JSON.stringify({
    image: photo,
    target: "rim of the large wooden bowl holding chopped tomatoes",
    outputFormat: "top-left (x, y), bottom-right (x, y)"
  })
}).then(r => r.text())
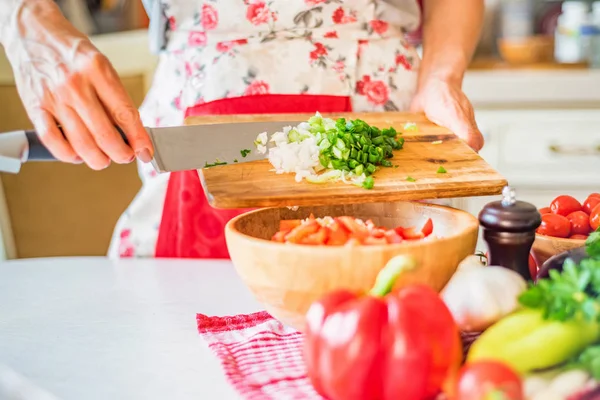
top-left (225, 200), bottom-right (479, 253)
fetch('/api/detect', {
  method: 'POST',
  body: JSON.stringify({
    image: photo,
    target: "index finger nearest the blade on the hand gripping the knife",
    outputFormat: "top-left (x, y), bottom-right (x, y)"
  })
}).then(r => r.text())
top-left (93, 53), bottom-right (154, 162)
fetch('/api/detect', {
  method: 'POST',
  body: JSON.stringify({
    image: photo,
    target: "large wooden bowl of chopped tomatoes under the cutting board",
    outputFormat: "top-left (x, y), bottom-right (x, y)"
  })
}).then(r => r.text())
top-left (225, 202), bottom-right (479, 331)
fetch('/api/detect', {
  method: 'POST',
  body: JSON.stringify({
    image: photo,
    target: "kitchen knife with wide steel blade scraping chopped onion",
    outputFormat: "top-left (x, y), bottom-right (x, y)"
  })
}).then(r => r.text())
top-left (0, 121), bottom-right (301, 173)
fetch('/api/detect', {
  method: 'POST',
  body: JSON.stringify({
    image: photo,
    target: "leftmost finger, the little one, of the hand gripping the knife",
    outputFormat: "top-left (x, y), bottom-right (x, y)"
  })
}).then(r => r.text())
top-left (29, 109), bottom-right (83, 164)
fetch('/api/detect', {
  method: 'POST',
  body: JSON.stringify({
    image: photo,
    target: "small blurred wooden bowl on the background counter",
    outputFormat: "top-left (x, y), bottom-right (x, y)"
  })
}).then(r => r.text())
top-left (498, 35), bottom-right (554, 65)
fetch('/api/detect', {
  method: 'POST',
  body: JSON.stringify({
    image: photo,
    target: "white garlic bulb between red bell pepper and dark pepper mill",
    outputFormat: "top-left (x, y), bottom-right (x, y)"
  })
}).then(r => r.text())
top-left (440, 255), bottom-right (527, 332)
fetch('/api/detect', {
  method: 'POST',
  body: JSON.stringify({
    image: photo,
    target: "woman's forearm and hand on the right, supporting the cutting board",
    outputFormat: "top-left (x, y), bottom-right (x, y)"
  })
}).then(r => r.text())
top-left (412, 0), bottom-right (484, 150)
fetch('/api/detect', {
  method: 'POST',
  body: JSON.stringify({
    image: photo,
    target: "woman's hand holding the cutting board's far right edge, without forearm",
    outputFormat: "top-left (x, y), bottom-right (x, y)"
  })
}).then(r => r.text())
top-left (411, 77), bottom-right (484, 151)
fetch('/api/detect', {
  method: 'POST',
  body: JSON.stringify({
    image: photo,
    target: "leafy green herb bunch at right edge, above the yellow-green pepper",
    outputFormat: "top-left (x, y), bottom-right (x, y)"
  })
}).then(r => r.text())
top-left (519, 231), bottom-right (600, 322)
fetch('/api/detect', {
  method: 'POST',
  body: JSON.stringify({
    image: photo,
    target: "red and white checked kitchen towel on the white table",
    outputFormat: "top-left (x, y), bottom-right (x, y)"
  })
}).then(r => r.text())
top-left (196, 312), bottom-right (476, 400)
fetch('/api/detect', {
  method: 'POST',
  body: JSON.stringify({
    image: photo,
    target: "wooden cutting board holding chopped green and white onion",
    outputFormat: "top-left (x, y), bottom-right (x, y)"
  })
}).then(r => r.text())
top-left (185, 112), bottom-right (507, 208)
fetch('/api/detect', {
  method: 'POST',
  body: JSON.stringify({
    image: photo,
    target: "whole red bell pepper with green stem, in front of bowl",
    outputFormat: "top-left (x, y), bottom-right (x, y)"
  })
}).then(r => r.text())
top-left (304, 256), bottom-right (462, 400)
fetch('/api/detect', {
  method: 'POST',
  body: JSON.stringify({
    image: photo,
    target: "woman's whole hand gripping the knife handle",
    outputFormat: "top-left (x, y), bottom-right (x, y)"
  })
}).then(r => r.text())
top-left (0, 0), bottom-right (153, 170)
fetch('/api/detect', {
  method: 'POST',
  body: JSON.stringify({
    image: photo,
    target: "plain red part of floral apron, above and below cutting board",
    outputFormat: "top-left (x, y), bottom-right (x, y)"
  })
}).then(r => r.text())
top-left (156, 94), bottom-right (352, 259)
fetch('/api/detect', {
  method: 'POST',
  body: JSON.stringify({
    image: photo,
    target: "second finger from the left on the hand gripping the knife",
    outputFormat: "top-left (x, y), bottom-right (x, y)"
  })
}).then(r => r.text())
top-left (57, 105), bottom-right (110, 170)
